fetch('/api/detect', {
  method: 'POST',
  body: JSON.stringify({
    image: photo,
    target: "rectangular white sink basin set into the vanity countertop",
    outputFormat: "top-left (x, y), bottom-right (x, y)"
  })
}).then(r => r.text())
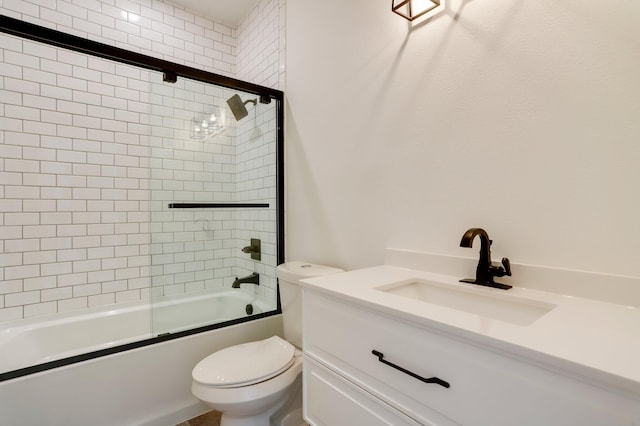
top-left (376, 279), bottom-right (556, 326)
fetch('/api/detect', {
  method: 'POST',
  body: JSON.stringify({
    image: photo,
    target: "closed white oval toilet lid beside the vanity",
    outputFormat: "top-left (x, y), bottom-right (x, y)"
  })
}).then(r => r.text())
top-left (192, 336), bottom-right (295, 388)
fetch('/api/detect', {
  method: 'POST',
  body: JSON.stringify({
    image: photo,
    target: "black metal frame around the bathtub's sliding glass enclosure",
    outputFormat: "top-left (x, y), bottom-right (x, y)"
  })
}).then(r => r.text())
top-left (0, 15), bottom-right (285, 382)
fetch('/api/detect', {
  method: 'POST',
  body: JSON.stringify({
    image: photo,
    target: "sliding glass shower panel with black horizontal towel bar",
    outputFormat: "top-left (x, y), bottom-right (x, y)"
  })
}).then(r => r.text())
top-left (149, 78), bottom-right (278, 336)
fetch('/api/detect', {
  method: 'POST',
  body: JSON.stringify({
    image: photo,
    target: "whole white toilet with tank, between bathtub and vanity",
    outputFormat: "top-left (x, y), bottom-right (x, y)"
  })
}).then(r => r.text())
top-left (191, 262), bottom-right (342, 426)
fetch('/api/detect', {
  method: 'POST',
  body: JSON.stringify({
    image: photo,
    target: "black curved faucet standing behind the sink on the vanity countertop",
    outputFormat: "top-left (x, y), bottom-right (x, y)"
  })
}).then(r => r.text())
top-left (460, 228), bottom-right (511, 290)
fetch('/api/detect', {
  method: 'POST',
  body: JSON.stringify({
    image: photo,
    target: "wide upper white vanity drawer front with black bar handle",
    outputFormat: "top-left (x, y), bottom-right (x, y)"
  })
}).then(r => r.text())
top-left (303, 289), bottom-right (640, 426)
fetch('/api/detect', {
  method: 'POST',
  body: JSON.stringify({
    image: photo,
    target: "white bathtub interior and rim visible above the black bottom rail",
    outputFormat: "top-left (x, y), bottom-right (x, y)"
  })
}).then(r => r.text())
top-left (0, 290), bottom-right (275, 373)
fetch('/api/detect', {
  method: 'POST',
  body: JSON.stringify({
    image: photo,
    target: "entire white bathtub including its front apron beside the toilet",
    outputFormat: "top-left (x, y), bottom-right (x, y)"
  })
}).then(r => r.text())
top-left (0, 290), bottom-right (282, 426)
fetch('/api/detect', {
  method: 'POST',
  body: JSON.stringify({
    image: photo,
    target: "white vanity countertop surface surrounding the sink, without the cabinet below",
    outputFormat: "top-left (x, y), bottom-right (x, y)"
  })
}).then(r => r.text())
top-left (302, 265), bottom-right (640, 397)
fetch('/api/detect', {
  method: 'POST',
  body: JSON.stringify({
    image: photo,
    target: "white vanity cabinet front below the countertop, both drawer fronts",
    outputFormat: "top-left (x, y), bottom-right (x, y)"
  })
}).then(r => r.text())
top-left (303, 287), bottom-right (640, 426)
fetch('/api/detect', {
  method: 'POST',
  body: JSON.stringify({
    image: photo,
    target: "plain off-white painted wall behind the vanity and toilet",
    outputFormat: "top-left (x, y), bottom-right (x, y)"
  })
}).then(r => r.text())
top-left (286, 0), bottom-right (640, 280)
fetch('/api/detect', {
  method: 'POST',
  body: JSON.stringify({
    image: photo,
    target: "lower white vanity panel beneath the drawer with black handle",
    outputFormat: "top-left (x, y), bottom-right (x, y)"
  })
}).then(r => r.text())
top-left (303, 357), bottom-right (438, 426)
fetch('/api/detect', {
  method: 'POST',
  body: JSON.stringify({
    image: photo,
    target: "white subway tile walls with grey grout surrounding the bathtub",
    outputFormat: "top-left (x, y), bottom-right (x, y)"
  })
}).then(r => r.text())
top-left (0, 0), bottom-right (284, 321)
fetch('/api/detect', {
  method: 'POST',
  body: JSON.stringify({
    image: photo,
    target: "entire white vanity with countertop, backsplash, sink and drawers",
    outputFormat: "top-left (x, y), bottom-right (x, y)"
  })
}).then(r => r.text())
top-left (302, 250), bottom-right (640, 426)
